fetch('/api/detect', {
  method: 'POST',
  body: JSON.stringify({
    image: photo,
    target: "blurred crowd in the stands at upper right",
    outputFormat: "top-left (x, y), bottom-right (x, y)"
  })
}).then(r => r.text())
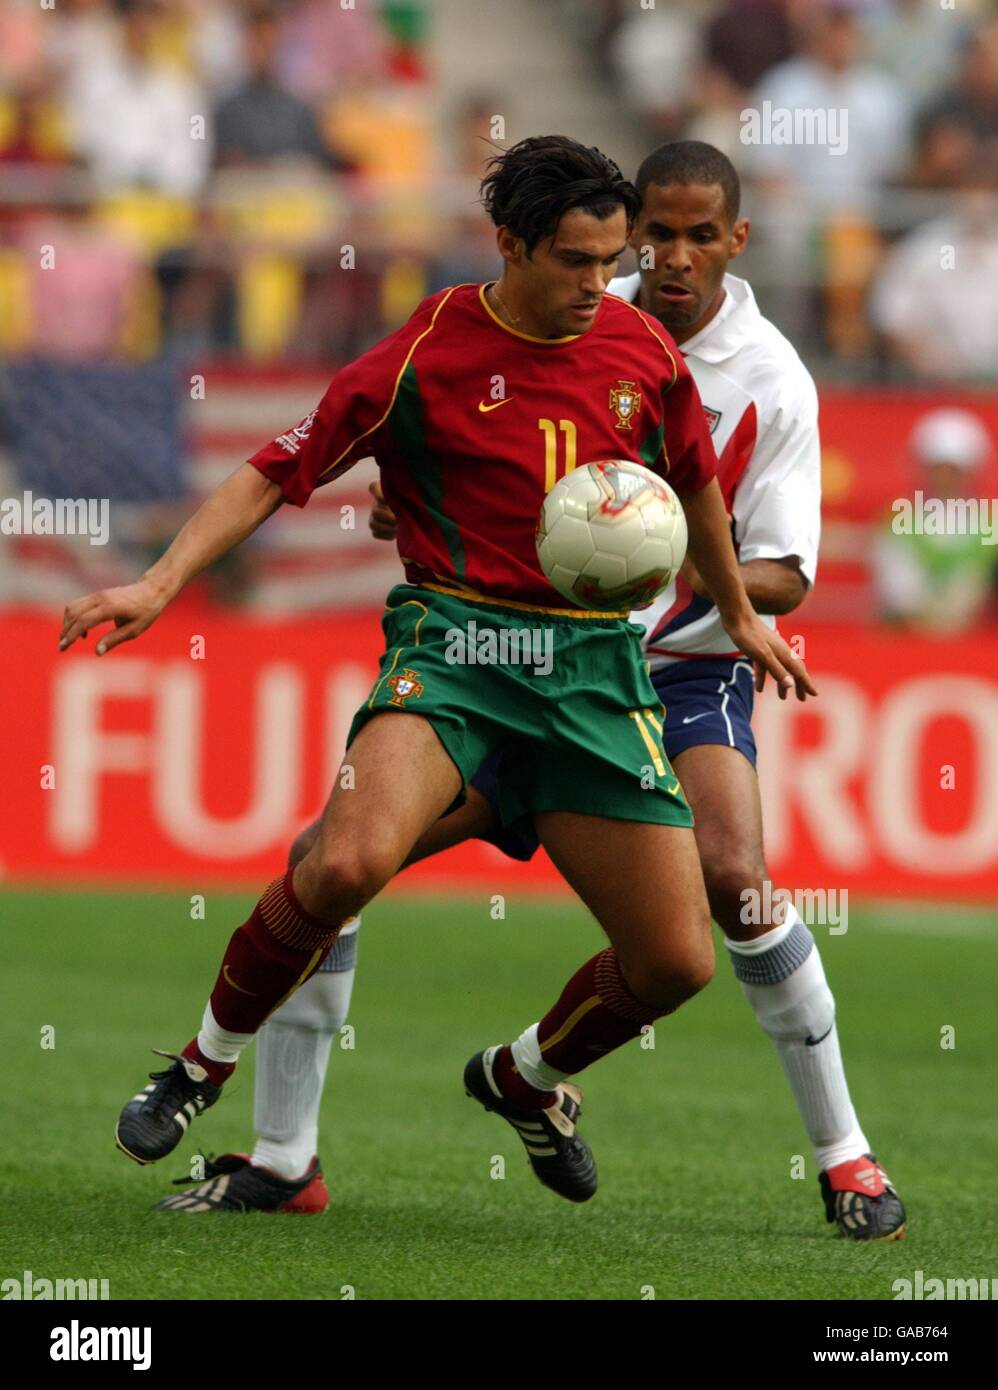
top-left (594, 0), bottom-right (998, 381)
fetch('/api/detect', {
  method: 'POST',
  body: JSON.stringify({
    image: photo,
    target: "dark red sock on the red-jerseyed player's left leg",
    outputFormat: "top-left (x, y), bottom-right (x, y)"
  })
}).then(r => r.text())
top-left (207, 869), bottom-right (343, 1039)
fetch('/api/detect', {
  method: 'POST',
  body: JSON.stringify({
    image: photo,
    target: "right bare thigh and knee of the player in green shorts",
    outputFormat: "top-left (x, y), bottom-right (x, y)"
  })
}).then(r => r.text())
top-left (537, 810), bottom-right (714, 1004)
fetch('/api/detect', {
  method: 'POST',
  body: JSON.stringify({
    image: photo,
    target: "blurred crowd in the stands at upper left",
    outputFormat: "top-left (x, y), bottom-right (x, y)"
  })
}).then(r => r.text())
top-left (0, 0), bottom-right (450, 361)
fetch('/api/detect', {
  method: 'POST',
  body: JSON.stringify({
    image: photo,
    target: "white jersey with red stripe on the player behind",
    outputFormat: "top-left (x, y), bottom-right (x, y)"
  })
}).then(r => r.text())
top-left (609, 274), bottom-right (821, 669)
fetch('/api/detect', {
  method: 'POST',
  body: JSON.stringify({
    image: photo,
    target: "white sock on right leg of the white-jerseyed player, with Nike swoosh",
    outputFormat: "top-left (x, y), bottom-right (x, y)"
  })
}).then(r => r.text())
top-left (724, 906), bottom-right (870, 1169)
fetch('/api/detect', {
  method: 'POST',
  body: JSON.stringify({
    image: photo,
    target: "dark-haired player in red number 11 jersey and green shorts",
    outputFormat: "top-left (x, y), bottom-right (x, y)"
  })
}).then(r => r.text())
top-left (60, 136), bottom-right (815, 1201)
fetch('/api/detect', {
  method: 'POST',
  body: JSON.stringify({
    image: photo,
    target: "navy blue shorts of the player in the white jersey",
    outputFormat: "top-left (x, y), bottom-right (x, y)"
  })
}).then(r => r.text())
top-left (471, 657), bottom-right (756, 859)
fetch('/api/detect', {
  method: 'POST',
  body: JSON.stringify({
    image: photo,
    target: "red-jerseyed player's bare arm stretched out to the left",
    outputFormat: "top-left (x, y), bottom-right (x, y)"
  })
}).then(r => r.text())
top-left (58, 463), bottom-right (281, 656)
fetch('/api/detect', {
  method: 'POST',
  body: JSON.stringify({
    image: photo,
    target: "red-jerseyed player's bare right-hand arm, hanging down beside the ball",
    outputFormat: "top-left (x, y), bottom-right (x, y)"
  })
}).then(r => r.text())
top-left (680, 478), bottom-right (817, 699)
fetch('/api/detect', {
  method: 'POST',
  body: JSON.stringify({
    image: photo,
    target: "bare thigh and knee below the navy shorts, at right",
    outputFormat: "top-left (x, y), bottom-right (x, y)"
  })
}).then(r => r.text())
top-left (673, 744), bottom-right (766, 940)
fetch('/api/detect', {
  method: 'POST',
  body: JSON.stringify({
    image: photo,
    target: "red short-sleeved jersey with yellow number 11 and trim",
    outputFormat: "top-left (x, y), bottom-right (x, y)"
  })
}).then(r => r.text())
top-left (250, 285), bottom-right (717, 606)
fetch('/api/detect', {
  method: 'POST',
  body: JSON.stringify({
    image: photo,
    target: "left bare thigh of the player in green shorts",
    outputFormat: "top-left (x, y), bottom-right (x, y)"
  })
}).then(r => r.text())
top-left (303, 713), bottom-right (461, 877)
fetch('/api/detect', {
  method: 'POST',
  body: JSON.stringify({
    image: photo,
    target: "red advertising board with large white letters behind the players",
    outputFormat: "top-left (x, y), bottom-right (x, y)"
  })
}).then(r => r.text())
top-left (0, 610), bottom-right (998, 901)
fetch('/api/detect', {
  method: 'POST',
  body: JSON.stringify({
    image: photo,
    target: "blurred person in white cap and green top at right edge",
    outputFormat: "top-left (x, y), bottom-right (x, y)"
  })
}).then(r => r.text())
top-left (873, 410), bottom-right (998, 632)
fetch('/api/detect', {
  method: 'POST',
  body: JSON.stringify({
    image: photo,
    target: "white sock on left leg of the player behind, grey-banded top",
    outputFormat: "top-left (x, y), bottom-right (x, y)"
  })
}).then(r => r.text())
top-left (252, 923), bottom-right (360, 1177)
